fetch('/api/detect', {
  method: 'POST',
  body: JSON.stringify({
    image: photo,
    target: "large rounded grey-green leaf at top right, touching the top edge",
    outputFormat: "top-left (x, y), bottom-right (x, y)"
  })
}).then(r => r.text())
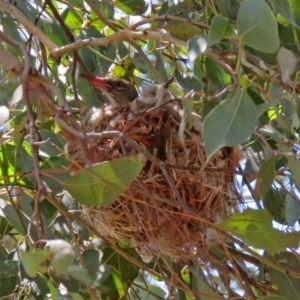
top-left (237, 0), bottom-right (280, 53)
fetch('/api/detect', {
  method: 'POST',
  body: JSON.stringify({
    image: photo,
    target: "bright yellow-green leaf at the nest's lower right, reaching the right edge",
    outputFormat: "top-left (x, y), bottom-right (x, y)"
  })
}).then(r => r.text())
top-left (216, 209), bottom-right (300, 255)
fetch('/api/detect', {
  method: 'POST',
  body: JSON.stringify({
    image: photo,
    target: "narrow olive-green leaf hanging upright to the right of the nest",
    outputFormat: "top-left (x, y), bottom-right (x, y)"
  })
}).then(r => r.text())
top-left (255, 156), bottom-right (275, 199)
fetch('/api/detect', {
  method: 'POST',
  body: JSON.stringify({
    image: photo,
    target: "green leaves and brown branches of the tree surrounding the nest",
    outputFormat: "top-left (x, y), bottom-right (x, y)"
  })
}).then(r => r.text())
top-left (0, 0), bottom-right (300, 299)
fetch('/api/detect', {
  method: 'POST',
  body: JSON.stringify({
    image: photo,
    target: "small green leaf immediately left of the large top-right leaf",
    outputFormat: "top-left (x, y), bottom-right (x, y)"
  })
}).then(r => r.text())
top-left (207, 16), bottom-right (234, 48)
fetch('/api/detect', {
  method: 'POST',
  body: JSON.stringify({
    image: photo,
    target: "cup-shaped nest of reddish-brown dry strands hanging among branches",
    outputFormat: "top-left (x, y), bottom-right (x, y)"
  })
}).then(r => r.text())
top-left (66, 102), bottom-right (239, 262)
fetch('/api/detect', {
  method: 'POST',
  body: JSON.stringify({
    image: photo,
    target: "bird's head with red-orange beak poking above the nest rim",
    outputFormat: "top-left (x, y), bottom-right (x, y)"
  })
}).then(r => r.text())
top-left (81, 74), bottom-right (138, 107)
